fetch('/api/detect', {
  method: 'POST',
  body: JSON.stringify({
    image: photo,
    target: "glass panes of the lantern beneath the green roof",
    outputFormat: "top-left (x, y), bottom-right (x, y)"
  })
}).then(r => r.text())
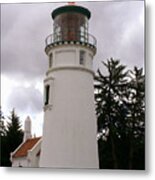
top-left (54, 12), bottom-right (88, 42)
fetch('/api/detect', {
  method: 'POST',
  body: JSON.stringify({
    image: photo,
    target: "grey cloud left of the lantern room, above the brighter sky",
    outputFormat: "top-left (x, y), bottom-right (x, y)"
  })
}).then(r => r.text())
top-left (1, 4), bottom-right (60, 78)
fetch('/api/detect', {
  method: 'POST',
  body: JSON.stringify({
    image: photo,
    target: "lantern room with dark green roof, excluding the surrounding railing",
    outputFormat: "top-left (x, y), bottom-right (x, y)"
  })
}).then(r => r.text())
top-left (52, 5), bottom-right (90, 42)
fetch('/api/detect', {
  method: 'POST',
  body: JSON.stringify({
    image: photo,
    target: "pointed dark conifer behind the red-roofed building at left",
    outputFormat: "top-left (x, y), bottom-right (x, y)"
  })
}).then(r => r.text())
top-left (1, 109), bottom-right (23, 166)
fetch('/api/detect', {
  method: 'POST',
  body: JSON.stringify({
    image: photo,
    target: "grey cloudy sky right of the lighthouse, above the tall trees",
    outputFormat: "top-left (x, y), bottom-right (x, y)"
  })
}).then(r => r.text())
top-left (83, 1), bottom-right (144, 69)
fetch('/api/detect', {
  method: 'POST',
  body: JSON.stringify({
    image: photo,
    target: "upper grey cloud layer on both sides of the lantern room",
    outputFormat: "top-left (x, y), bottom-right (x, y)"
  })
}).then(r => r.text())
top-left (1, 1), bottom-right (144, 78)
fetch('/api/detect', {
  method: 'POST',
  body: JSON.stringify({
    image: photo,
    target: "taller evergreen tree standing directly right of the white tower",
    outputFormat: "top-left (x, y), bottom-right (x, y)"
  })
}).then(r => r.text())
top-left (95, 58), bottom-right (127, 169)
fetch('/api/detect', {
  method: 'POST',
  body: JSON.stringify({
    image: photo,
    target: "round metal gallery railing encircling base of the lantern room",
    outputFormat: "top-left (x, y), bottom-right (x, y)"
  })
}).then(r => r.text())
top-left (45, 32), bottom-right (97, 47)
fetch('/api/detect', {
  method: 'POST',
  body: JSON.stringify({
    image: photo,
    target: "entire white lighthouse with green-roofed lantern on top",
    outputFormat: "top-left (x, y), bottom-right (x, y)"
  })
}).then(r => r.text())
top-left (40, 4), bottom-right (98, 168)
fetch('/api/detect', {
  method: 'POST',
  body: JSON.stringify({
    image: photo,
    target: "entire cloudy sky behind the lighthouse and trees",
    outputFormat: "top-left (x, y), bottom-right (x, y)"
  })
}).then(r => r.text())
top-left (1, 1), bottom-right (144, 135)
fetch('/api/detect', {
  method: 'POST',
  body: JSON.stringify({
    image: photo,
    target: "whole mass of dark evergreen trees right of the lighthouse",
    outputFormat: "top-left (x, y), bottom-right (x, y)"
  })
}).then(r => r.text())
top-left (95, 58), bottom-right (145, 169)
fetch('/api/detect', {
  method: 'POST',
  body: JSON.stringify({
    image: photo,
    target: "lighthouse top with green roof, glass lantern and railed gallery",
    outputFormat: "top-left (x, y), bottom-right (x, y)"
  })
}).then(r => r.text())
top-left (46, 4), bottom-right (96, 52)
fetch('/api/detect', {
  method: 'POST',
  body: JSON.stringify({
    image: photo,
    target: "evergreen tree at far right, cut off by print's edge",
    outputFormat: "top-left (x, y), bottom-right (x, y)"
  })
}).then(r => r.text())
top-left (126, 67), bottom-right (145, 169)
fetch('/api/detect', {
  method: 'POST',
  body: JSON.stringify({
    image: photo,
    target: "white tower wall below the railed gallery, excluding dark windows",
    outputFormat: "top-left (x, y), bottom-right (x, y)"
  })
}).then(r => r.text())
top-left (40, 45), bottom-right (98, 168)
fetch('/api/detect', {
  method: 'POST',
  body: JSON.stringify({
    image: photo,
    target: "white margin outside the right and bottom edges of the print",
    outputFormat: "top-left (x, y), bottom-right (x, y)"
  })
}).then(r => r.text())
top-left (0, 0), bottom-right (155, 180)
